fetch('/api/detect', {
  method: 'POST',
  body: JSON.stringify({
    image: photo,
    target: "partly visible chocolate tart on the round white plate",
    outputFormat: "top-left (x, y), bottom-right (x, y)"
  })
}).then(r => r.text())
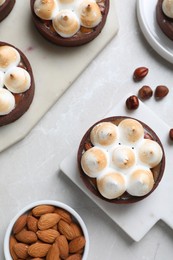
top-left (156, 0), bottom-right (173, 40)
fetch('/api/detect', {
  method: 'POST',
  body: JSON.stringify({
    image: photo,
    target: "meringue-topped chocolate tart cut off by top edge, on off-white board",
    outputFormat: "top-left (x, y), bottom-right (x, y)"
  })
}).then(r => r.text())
top-left (30, 0), bottom-right (109, 47)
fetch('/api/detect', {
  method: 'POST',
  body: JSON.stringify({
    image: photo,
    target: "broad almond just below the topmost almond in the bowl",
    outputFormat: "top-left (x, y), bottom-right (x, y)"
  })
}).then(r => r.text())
top-left (38, 213), bottom-right (60, 230)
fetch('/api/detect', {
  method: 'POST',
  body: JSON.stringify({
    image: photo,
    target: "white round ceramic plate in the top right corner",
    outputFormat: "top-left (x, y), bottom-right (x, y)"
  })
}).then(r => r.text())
top-left (137, 0), bottom-right (173, 63)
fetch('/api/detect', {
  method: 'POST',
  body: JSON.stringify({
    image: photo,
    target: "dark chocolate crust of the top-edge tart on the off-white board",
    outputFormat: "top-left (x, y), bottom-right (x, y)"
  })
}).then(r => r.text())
top-left (30, 0), bottom-right (109, 47)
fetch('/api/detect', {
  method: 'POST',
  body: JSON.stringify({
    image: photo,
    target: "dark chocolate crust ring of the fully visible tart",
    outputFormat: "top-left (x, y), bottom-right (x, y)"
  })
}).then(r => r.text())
top-left (77, 116), bottom-right (165, 204)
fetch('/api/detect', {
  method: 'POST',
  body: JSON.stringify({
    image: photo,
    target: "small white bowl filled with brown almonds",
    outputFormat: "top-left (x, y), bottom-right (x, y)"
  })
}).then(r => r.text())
top-left (4, 200), bottom-right (89, 260)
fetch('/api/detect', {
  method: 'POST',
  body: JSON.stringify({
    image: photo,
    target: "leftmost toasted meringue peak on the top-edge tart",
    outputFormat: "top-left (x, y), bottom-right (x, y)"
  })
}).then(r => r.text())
top-left (34, 0), bottom-right (57, 20)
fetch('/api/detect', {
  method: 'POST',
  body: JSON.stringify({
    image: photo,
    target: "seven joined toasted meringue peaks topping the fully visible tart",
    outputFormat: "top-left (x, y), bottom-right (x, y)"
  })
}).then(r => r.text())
top-left (81, 118), bottom-right (163, 199)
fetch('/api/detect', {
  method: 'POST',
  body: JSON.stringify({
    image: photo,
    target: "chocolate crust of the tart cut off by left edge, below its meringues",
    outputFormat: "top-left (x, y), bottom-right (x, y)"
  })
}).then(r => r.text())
top-left (0, 42), bottom-right (35, 126)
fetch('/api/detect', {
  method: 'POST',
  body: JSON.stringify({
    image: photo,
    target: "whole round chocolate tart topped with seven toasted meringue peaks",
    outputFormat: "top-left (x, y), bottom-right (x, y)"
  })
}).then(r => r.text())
top-left (77, 116), bottom-right (165, 204)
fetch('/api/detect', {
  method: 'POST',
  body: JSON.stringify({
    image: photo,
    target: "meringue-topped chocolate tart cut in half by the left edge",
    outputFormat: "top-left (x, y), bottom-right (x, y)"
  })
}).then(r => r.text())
top-left (0, 42), bottom-right (35, 126)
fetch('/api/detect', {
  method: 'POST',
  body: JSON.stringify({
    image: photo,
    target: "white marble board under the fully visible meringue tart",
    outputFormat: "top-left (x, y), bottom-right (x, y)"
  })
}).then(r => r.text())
top-left (60, 94), bottom-right (173, 241)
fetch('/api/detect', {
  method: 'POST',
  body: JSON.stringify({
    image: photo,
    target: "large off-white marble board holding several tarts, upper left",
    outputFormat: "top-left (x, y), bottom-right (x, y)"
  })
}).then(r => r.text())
top-left (0, 0), bottom-right (118, 152)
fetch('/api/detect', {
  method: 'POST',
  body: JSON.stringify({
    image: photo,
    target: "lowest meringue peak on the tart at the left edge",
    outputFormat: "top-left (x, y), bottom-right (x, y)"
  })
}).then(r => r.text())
top-left (0, 88), bottom-right (15, 116)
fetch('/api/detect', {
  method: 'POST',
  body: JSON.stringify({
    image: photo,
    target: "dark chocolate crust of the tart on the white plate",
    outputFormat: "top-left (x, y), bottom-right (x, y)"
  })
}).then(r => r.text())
top-left (156, 0), bottom-right (173, 40)
